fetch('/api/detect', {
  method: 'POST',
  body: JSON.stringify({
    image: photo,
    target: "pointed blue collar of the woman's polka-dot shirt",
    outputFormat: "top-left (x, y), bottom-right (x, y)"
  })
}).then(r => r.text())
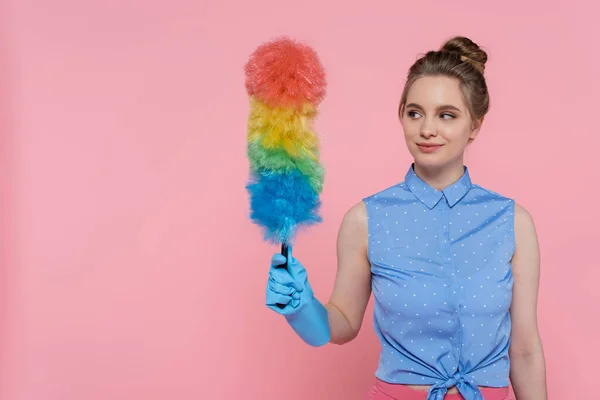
top-left (404, 163), bottom-right (472, 209)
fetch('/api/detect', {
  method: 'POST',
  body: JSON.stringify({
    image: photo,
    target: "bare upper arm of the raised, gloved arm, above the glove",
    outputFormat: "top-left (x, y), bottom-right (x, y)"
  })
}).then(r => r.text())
top-left (325, 202), bottom-right (371, 344)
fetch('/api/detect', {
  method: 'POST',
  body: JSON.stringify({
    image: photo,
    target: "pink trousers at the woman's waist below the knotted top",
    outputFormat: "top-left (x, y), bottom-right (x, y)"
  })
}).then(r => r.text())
top-left (365, 379), bottom-right (514, 400)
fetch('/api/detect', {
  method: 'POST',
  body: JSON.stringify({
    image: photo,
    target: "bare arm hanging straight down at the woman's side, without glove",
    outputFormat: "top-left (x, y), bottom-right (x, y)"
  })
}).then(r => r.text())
top-left (510, 204), bottom-right (548, 400)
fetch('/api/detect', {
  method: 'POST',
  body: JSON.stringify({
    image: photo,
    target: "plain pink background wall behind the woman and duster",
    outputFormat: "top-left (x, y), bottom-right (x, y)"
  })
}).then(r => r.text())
top-left (0, 0), bottom-right (600, 400)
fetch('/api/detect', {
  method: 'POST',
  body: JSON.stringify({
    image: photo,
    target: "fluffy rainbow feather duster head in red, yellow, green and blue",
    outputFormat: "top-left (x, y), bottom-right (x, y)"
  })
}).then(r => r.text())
top-left (245, 37), bottom-right (326, 249)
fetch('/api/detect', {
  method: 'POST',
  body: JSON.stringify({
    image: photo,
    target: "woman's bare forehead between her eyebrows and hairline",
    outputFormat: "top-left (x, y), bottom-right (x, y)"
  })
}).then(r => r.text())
top-left (406, 76), bottom-right (466, 109)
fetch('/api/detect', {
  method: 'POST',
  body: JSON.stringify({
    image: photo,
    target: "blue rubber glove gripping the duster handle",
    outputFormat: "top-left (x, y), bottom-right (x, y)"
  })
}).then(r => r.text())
top-left (267, 247), bottom-right (330, 347)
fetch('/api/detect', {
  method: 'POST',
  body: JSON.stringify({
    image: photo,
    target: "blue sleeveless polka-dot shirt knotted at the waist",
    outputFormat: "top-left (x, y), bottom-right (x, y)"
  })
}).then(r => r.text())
top-left (363, 164), bottom-right (515, 400)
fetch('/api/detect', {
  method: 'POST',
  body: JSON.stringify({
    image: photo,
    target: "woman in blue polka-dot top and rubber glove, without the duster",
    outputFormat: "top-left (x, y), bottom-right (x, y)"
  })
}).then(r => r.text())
top-left (267, 37), bottom-right (547, 400)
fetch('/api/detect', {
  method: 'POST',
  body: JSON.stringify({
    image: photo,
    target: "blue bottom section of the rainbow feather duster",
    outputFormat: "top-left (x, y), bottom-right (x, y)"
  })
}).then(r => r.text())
top-left (246, 170), bottom-right (322, 244)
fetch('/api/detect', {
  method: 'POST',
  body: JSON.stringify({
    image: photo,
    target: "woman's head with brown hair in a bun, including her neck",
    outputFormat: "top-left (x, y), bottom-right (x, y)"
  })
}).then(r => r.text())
top-left (398, 37), bottom-right (490, 186)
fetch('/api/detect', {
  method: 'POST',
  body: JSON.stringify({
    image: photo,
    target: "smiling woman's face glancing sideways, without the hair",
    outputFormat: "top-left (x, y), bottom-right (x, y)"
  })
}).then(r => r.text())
top-left (401, 76), bottom-right (481, 168)
